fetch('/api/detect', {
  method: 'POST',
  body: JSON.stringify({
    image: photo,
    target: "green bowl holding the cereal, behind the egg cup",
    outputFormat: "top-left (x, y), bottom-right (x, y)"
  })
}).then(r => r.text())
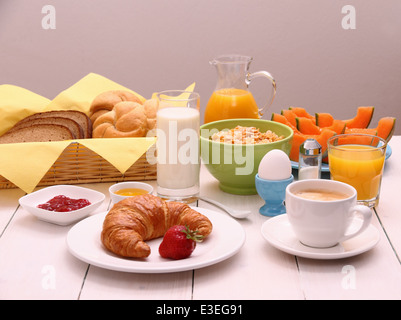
top-left (200, 119), bottom-right (294, 195)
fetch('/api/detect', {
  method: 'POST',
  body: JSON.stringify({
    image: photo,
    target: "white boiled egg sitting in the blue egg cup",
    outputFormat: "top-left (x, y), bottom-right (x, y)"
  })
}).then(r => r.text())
top-left (258, 149), bottom-right (292, 180)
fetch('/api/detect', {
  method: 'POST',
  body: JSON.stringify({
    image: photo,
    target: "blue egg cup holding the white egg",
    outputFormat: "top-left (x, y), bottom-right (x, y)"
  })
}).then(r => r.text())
top-left (255, 174), bottom-right (294, 217)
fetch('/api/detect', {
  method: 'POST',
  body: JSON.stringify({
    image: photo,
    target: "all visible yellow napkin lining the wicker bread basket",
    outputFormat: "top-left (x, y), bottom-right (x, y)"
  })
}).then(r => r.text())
top-left (0, 73), bottom-right (195, 193)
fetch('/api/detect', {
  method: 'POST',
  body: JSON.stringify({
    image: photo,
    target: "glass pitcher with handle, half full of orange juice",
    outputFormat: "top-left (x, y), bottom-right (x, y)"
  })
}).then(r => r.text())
top-left (204, 55), bottom-right (276, 123)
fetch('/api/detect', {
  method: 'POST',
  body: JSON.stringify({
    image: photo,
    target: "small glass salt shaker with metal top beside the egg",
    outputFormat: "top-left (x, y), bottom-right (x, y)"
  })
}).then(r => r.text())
top-left (298, 139), bottom-right (322, 180)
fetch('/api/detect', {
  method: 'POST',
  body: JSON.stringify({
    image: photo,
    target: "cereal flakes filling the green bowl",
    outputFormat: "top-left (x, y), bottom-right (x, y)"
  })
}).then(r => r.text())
top-left (211, 126), bottom-right (283, 144)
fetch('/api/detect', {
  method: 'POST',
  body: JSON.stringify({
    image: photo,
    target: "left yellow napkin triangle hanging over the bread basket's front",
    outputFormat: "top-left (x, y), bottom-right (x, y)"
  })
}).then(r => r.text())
top-left (0, 141), bottom-right (71, 193)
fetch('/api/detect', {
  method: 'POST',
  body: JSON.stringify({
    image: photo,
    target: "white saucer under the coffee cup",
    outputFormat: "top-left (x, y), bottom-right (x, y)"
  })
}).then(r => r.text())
top-left (261, 214), bottom-right (380, 260)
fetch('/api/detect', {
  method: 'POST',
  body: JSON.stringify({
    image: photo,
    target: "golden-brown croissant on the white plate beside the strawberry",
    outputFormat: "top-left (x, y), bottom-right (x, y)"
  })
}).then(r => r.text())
top-left (101, 194), bottom-right (213, 258)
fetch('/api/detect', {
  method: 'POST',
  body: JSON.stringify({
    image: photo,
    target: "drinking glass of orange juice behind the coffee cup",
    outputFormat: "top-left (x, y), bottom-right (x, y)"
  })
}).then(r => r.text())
top-left (327, 133), bottom-right (387, 207)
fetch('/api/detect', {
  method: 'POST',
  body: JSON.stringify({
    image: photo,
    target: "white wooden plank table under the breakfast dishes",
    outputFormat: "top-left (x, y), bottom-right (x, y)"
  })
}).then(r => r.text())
top-left (0, 136), bottom-right (401, 300)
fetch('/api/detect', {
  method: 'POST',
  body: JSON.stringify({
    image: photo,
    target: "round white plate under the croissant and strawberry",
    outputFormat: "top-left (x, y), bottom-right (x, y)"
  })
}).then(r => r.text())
top-left (67, 208), bottom-right (245, 273)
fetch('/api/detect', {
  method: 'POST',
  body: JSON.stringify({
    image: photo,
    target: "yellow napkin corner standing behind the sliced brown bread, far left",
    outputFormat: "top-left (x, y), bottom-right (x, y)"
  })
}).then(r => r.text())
top-left (0, 84), bottom-right (50, 136)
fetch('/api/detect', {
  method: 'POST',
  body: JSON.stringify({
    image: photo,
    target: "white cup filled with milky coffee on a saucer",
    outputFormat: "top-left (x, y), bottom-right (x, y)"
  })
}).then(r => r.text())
top-left (285, 179), bottom-right (372, 248)
